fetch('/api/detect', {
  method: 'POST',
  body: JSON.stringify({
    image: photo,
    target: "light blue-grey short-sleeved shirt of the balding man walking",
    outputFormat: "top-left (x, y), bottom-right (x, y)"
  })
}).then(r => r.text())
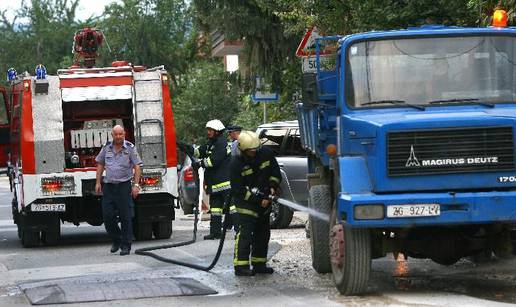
top-left (95, 140), bottom-right (142, 183)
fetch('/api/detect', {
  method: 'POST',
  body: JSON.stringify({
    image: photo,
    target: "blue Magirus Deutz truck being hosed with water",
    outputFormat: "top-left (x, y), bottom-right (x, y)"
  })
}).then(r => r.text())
top-left (296, 12), bottom-right (516, 295)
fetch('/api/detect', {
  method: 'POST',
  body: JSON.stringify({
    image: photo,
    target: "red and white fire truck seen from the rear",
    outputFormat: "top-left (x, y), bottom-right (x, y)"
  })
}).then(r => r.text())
top-left (9, 29), bottom-right (177, 247)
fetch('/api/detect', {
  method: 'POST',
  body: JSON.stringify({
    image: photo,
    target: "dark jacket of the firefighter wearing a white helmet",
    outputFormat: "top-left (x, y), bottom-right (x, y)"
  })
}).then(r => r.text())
top-left (194, 135), bottom-right (231, 194)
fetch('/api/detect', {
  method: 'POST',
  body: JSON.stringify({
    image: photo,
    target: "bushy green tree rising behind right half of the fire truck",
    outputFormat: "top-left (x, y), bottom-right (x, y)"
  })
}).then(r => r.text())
top-left (99, 0), bottom-right (197, 90)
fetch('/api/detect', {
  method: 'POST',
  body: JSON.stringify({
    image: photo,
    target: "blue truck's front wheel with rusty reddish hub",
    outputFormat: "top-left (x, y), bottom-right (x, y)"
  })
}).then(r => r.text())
top-left (330, 206), bottom-right (371, 295)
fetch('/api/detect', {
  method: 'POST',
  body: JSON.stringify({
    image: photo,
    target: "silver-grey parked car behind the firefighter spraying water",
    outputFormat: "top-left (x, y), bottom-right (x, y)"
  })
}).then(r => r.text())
top-left (256, 120), bottom-right (308, 228)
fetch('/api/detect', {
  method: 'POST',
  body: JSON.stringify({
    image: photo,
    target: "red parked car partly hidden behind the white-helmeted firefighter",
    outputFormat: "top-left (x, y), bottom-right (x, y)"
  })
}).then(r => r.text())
top-left (177, 151), bottom-right (200, 214)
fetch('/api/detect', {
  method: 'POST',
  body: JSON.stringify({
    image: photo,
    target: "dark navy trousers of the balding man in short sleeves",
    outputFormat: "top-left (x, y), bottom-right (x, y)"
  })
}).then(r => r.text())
top-left (102, 181), bottom-right (134, 249)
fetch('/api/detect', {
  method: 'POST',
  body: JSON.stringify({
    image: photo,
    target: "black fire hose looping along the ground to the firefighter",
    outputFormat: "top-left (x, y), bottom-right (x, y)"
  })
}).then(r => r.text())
top-left (134, 144), bottom-right (229, 272)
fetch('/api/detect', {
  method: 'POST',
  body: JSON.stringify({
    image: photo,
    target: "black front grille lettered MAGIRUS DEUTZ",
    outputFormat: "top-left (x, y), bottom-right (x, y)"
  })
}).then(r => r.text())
top-left (387, 127), bottom-right (515, 176)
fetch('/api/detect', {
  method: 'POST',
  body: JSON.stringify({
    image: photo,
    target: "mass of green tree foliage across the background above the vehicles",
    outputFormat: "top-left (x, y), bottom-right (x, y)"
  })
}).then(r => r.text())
top-left (0, 0), bottom-right (516, 138)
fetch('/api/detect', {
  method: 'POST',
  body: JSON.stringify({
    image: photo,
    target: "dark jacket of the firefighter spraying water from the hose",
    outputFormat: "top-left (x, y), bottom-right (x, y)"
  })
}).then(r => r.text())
top-left (231, 147), bottom-right (281, 217)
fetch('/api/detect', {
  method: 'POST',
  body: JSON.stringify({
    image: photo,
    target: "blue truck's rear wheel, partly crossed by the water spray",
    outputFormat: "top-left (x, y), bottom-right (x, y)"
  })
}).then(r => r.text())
top-left (308, 185), bottom-right (331, 273)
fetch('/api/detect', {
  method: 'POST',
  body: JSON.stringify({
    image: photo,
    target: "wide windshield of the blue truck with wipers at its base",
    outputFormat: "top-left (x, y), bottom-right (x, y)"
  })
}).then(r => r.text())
top-left (346, 36), bottom-right (516, 108)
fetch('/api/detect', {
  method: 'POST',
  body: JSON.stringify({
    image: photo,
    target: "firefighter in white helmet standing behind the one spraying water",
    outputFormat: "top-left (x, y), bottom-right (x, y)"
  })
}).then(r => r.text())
top-left (192, 119), bottom-right (231, 240)
